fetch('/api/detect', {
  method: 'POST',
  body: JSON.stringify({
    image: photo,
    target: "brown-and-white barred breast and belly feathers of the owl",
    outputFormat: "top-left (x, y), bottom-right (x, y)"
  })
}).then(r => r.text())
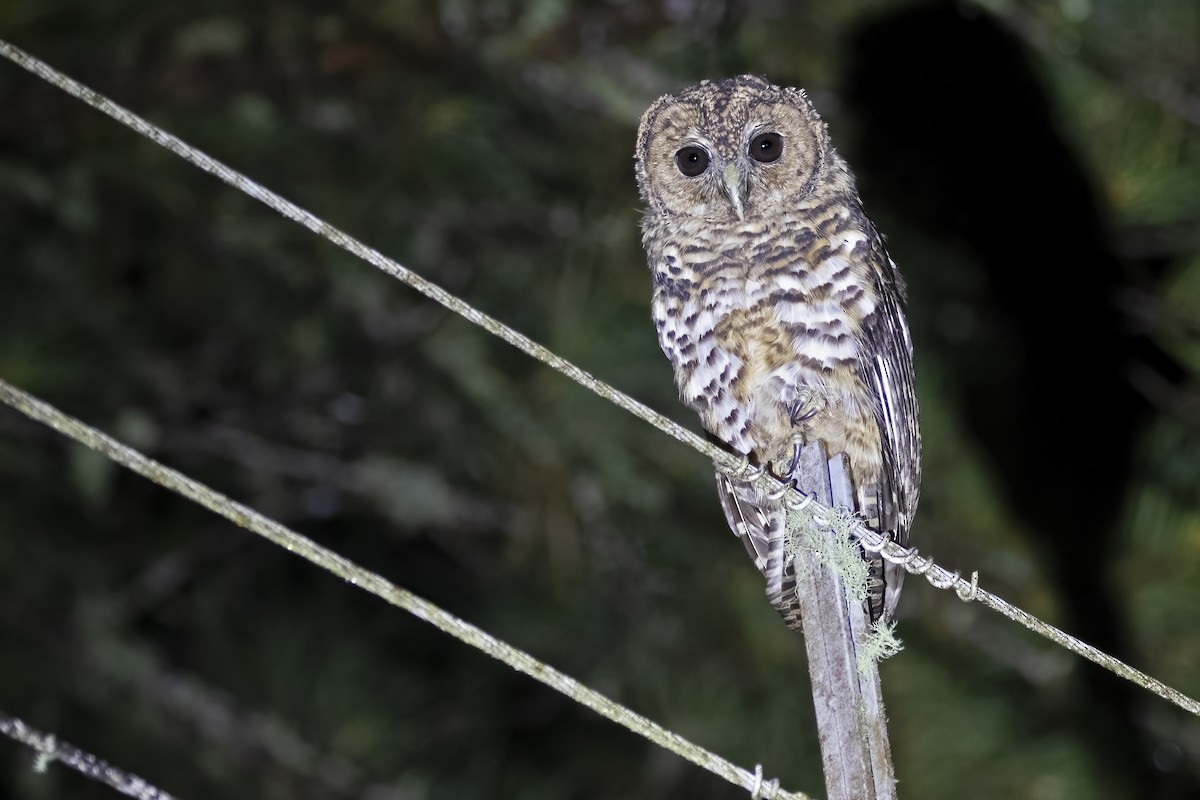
top-left (647, 205), bottom-right (882, 477)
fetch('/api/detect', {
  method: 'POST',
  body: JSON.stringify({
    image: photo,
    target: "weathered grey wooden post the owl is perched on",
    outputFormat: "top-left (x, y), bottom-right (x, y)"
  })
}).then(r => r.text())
top-left (794, 444), bottom-right (896, 800)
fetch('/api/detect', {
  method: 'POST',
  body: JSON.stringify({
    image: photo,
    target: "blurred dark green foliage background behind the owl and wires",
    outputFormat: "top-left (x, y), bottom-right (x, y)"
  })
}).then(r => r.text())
top-left (0, 0), bottom-right (1200, 800)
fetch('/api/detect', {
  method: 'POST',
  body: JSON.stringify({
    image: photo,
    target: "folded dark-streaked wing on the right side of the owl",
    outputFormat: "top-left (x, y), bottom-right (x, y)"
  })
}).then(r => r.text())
top-left (859, 248), bottom-right (920, 619)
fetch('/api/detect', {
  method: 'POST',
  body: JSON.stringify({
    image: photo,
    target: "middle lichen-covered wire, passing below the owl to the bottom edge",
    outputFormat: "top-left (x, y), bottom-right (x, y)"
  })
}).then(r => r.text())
top-left (0, 379), bottom-right (809, 800)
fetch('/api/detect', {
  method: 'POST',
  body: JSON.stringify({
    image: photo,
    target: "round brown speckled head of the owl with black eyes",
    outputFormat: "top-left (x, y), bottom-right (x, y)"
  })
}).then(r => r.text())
top-left (637, 76), bottom-right (833, 222)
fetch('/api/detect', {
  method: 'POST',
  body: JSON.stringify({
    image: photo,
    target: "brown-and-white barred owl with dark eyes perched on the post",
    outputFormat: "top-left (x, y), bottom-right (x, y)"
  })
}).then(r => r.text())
top-left (636, 76), bottom-right (920, 627)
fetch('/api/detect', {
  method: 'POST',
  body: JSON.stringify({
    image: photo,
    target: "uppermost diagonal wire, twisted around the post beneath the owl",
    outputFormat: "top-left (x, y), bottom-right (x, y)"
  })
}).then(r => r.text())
top-left (0, 40), bottom-right (1200, 716)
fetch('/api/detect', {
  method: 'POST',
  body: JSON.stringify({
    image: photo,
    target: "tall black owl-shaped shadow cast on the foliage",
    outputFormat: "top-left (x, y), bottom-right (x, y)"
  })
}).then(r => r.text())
top-left (846, 2), bottom-right (1198, 799)
